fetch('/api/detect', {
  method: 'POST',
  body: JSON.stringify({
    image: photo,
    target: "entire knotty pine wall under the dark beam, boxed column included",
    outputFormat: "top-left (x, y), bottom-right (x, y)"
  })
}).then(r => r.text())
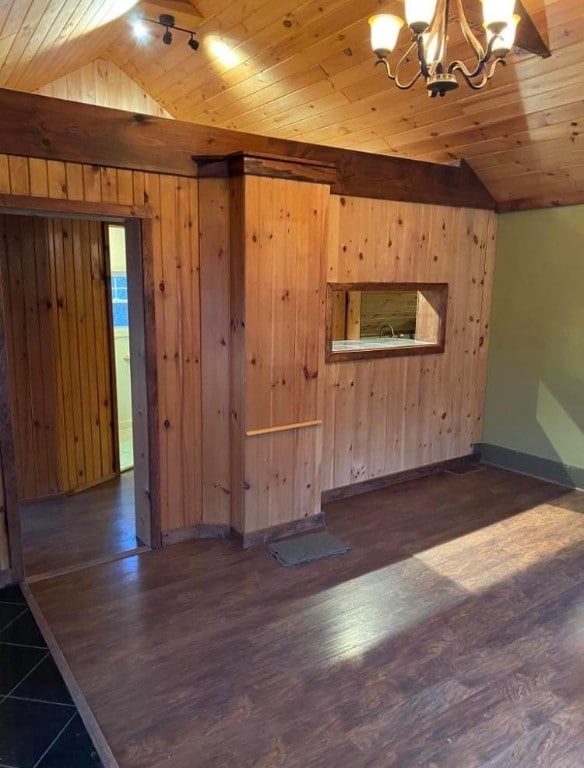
top-left (0, 146), bottom-right (495, 568)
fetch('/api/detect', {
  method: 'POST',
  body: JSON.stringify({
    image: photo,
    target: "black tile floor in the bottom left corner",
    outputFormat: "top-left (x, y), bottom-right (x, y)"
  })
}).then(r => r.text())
top-left (0, 587), bottom-right (102, 768)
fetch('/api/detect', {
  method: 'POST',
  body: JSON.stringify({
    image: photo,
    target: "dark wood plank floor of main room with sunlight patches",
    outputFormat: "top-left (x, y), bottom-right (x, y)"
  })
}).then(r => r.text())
top-left (32, 468), bottom-right (584, 768)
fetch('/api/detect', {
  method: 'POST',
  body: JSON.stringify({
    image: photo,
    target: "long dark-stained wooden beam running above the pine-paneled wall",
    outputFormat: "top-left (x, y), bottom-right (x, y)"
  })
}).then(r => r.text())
top-left (0, 89), bottom-right (496, 210)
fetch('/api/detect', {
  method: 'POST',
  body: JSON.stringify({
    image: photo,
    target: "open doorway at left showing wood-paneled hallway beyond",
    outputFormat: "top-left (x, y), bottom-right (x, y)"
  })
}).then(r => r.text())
top-left (0, 215), bottom-right (156, 579)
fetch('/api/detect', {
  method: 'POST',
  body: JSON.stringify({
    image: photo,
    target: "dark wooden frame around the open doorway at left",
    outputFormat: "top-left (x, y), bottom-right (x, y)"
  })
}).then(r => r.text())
top-left (0, 194), bottom-right (162, 582)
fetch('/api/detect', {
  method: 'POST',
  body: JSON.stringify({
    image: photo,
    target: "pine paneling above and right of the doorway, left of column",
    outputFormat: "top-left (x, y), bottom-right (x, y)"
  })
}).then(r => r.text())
top-left (0, 155), bottom-right (201, 531)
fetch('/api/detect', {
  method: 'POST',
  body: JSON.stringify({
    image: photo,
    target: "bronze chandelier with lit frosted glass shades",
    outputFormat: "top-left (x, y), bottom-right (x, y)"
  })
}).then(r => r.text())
top-left (369, 0), bottom-right (521, 97)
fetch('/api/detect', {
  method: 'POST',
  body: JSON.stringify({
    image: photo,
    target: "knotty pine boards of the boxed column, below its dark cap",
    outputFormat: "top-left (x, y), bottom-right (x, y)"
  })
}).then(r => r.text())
top-left (231, 170), bottom-right (330, 543)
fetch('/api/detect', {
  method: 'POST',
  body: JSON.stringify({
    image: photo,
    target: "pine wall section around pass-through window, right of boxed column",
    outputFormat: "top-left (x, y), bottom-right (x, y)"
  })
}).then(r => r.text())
top-left (323, 196), bottom-right (495, 489)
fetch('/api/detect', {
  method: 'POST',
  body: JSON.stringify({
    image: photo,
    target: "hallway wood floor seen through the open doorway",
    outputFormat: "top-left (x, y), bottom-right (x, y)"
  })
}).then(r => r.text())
top-left (21, 472), bottom-right (139, 576)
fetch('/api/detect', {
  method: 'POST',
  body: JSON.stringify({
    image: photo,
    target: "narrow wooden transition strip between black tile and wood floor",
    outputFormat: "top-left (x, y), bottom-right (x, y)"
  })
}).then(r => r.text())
top-left (22, 583), bottom-right (119, 768)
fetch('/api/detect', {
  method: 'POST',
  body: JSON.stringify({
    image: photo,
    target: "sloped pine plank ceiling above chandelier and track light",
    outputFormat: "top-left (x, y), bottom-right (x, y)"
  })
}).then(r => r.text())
top-left (0, 0), bottom-right (584, 207)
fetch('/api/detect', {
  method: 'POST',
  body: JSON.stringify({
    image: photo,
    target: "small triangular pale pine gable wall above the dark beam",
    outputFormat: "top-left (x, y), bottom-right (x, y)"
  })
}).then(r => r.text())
top-left (34, 59), bottom-right (172, 118)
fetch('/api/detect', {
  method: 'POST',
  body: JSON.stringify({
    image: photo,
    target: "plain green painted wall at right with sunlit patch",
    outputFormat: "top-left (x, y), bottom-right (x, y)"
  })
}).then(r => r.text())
top-left (483, 206), bottom-right (584, 477)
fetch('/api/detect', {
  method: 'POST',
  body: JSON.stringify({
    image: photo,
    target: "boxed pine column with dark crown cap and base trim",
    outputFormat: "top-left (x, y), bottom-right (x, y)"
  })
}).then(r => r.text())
top-left (199, 154), bottom-right (335, 546)
